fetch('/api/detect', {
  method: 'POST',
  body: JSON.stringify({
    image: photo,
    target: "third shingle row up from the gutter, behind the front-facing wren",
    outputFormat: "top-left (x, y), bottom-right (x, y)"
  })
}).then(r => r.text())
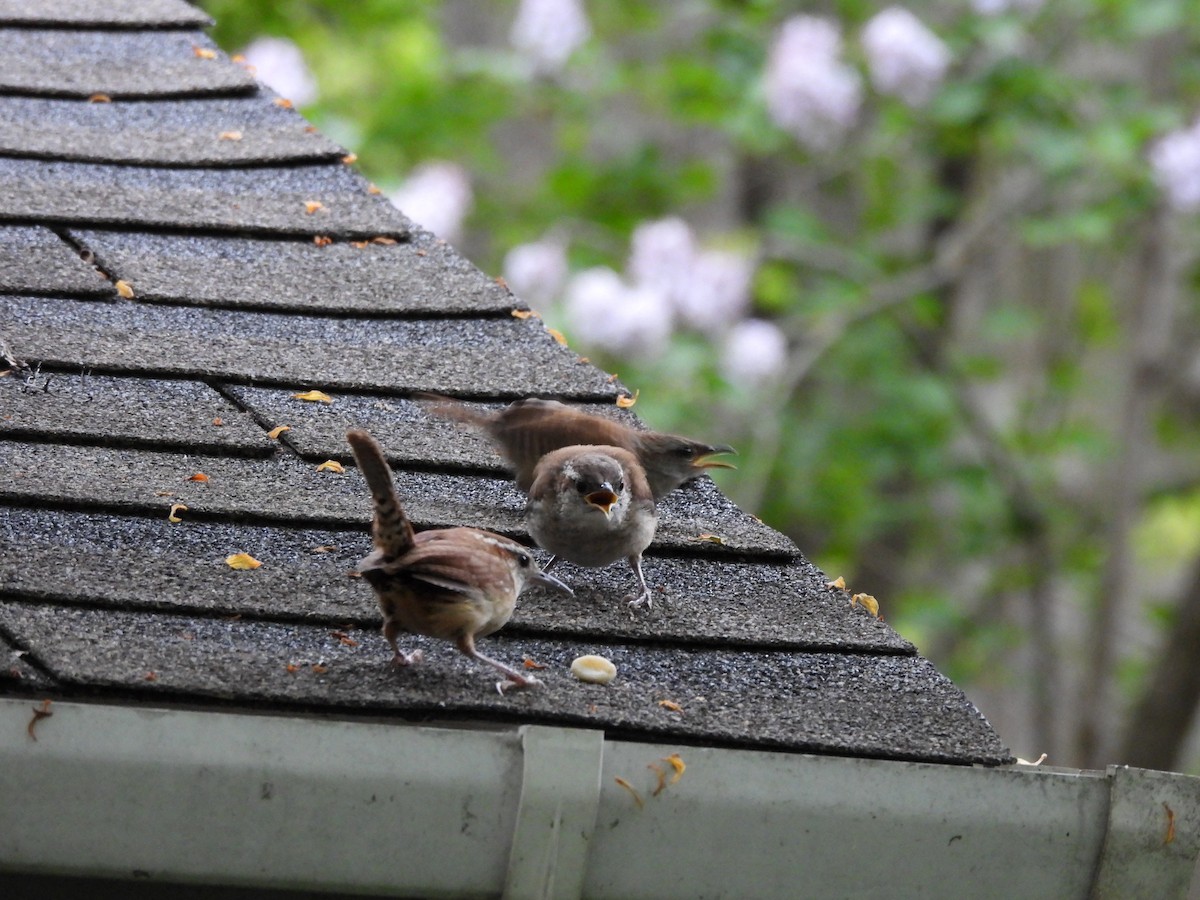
top-left (0, 442), bottom-right (796, 558)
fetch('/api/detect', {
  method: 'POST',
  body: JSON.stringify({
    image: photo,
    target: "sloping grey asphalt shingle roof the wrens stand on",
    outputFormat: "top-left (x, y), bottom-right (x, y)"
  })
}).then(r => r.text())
top-left (0, 0), bottom-right (1009, 764)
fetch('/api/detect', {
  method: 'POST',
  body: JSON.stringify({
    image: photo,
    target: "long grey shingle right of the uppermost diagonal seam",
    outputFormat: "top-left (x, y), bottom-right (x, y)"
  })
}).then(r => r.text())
top-left (71, 230), bottom-right (520, 316)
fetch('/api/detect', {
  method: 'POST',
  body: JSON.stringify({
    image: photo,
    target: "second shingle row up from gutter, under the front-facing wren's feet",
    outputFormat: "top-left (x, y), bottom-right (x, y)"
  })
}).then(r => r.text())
top-left (0, 508), bottom-right (913, 655)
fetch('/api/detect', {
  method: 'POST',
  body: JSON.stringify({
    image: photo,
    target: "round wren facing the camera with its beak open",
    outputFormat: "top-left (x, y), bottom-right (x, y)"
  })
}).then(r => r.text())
top-left (526, 445), bottom-right (659, 607)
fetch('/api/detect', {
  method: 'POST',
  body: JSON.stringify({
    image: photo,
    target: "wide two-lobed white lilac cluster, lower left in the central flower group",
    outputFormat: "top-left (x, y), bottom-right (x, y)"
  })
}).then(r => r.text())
top-left (565, 266), bottom-right (671, 358)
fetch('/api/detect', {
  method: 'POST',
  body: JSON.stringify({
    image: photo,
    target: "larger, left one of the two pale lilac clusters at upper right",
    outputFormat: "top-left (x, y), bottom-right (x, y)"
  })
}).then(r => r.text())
top-left (763, 16), bottom-right (862, 150)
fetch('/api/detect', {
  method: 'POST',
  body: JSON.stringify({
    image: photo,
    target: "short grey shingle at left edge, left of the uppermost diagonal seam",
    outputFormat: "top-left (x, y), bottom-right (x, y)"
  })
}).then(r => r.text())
top-left (0, 226), bottom-right (113, 296)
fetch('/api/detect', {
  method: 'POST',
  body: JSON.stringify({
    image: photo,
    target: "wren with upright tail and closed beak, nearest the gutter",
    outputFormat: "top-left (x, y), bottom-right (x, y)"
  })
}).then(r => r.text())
top-left (346, 430), bottom-right (574, 694)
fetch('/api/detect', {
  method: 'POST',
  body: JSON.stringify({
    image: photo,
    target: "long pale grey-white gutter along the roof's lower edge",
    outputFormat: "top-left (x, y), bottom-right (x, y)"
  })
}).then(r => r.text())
top-left (0, 698), bottom-right (1200, 900)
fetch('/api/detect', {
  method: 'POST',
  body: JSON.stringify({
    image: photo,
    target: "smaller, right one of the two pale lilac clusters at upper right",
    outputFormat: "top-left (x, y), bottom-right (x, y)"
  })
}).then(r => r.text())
top-left (862, 6), bottom-right (950, 107)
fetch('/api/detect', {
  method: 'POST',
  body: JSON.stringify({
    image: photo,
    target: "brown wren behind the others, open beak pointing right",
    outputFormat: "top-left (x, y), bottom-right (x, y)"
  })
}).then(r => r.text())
top-left (422, 395), bottom-right (734, 500)
